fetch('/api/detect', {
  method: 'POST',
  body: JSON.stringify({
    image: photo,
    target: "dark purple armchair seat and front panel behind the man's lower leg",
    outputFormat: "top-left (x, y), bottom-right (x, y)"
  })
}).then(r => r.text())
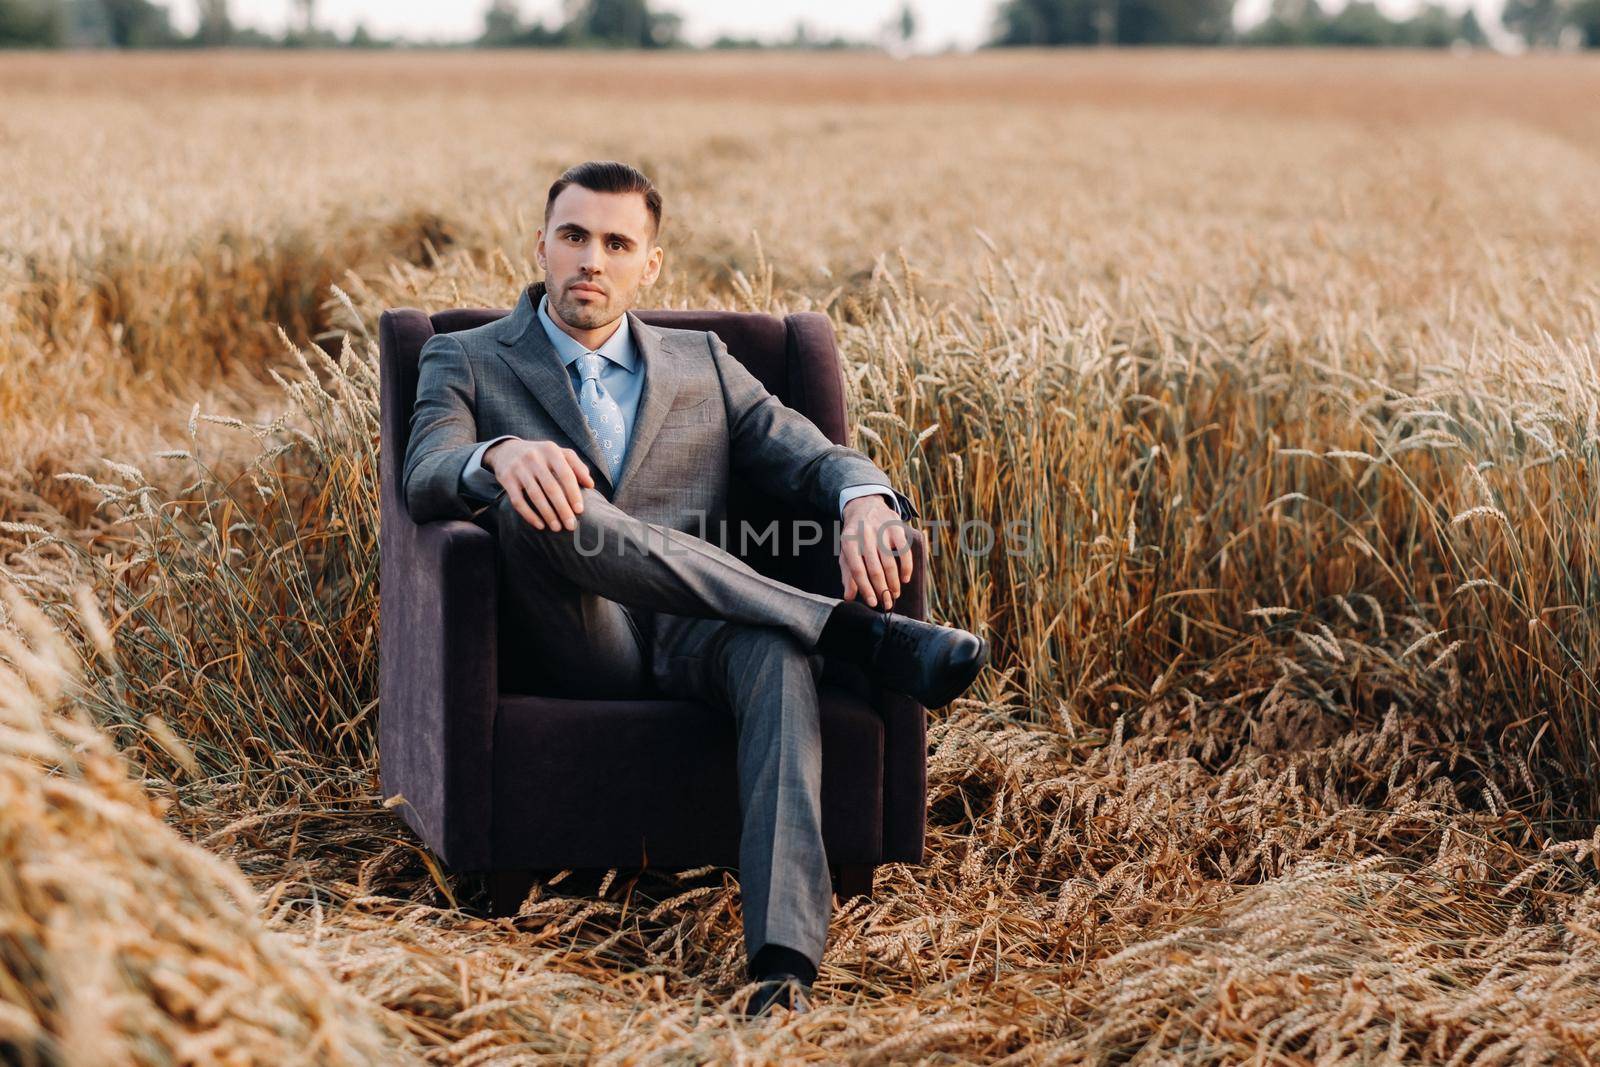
top-left (491, 677), bottom-right (883, 869)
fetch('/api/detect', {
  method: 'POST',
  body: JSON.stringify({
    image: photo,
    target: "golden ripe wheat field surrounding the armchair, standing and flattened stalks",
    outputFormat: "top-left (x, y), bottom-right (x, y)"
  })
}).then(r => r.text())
top-left (0, 50), bottom-right (1600, 1064)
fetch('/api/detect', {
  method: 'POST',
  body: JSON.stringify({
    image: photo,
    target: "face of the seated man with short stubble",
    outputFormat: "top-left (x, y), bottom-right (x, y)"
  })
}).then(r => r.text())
top-left (536, 186), bottom-right (664, 330)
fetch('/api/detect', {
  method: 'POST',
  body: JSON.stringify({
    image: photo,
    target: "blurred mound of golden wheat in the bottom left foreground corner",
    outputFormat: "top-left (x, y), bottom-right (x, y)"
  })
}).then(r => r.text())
top-left (0, 585), bottom-right (403, 1064)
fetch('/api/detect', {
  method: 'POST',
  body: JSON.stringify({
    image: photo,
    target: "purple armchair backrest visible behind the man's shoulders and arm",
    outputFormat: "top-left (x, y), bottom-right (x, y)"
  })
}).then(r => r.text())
top-left (378, 300), bottom-right (850, 597)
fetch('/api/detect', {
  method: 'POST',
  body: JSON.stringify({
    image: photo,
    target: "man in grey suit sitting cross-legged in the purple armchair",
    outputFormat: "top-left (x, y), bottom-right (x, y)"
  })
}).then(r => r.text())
top-left (405, 162), bottom-right (987, 1013)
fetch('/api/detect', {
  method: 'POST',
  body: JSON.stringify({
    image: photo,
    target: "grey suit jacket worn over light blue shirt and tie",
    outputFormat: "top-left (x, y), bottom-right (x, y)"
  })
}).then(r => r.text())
top-left (403, 282), bottom-right (917, 536)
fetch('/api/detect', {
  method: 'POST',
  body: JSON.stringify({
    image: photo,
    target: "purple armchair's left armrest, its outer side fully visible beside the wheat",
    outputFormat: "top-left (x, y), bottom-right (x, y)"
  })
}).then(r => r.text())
top-left (378, 494), bottom-right (499, 870)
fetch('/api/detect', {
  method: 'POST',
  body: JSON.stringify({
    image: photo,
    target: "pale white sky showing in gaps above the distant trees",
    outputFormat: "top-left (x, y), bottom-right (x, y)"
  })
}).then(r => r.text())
top-left (170, 0), bottom-right (1502, 51)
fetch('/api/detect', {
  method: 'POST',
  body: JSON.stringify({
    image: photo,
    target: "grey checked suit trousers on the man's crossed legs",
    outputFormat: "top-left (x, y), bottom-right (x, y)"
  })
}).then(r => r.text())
top-left (478, 488), bottom-right (840, 965)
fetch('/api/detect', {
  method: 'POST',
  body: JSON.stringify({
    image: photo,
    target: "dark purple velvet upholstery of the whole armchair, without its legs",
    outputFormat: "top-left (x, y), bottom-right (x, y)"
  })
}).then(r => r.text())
top-left (378, 299), bottom-right (928, 870)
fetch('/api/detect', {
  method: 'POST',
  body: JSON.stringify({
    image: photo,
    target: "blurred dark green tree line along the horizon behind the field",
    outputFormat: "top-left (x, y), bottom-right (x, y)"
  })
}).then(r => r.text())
top-left (0, 0), bottom-right (1600, 48)
